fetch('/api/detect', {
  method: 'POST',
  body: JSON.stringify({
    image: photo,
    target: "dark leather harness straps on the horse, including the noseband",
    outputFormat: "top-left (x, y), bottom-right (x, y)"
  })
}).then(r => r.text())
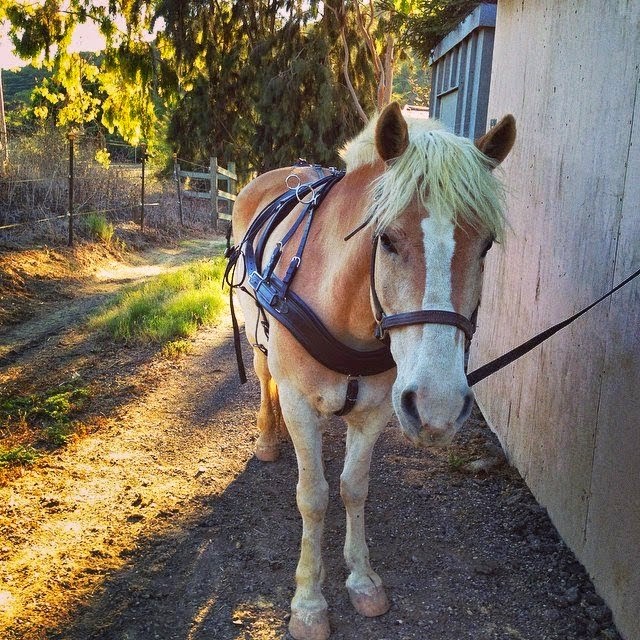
top-left (225, 169), bottom-right (474, 415)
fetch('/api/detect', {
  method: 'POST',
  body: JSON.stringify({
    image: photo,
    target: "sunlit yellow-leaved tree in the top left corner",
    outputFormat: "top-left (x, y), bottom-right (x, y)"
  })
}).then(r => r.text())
top-left (0, 0), bottom-right (162, 151)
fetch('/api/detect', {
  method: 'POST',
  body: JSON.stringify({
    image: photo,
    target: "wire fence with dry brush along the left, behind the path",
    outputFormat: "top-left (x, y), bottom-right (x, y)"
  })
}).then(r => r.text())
top-left (0, 132), bottom-right (238, 245)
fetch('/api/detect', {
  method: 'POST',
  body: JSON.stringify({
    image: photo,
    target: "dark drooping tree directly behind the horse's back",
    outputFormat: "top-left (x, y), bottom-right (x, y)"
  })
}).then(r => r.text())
top-left (159, 0), bottom-right (373, 171)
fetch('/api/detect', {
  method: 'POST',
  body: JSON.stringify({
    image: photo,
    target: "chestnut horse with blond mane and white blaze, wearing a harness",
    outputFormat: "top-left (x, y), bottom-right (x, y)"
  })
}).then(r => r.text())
top-left (233, 103), bottom-right (515, 640)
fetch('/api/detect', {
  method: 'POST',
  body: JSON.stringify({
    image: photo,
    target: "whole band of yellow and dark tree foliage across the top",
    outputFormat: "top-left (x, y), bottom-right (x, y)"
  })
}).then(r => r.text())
top-left (0, 0), bottom-right (448, 180)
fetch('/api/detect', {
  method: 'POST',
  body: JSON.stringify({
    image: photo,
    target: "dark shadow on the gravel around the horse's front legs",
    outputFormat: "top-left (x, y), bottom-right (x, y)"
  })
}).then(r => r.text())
top-left (47, 342), bottom-right (618, 640)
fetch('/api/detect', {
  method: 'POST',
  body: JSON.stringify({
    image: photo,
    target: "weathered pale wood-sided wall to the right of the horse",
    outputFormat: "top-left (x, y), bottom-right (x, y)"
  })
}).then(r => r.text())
top-left (471, 0), bottom-right (640, 640)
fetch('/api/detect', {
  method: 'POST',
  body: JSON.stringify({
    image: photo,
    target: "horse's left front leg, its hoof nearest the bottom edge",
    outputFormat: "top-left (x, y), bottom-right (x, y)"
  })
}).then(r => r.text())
top-left (280, 389), bottom-right (330, 640)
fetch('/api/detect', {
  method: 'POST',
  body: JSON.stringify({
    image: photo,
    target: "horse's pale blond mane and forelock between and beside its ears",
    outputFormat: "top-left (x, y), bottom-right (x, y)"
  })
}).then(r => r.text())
top-left (341, 111), bottom-right (505, 241)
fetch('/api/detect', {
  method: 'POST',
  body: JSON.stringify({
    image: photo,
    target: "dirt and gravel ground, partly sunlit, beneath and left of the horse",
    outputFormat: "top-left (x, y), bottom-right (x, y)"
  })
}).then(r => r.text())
top-left (0, 238), bottom-right (620, 640)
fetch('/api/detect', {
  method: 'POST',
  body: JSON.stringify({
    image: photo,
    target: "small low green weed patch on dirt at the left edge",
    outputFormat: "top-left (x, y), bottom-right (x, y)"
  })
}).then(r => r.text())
top-left (0, 384), bottom-right (89, 452)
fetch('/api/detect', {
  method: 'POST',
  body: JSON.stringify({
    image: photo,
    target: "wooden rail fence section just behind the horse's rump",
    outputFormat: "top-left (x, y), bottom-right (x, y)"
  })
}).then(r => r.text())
top-left (173, 153), bottom-right (238, 229)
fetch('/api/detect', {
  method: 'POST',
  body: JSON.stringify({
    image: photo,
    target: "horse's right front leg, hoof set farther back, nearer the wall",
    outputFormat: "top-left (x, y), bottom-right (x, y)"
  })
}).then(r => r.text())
top-left (340, 413), bottom-right (389, 617)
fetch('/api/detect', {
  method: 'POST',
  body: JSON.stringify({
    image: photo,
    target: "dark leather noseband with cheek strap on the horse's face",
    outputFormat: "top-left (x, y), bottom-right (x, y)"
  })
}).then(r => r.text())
top-left (369, 233), bottom-right (476, 342)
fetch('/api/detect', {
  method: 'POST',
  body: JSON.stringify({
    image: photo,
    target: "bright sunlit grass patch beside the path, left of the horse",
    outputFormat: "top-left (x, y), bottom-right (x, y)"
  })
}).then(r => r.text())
top-left (93, 258), bottom-right (226, 345)
